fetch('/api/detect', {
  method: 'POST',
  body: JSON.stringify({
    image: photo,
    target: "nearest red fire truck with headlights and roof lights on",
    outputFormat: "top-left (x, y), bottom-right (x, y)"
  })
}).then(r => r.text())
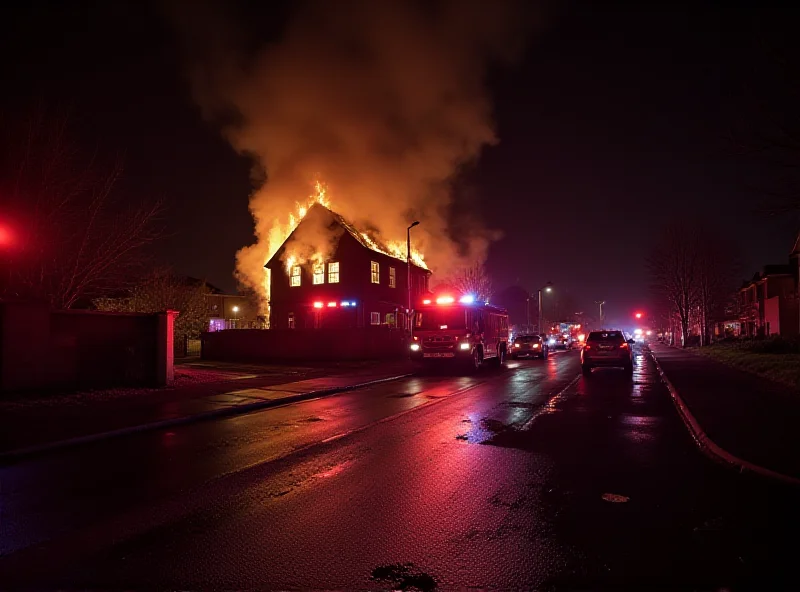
top-left (410, 295), bottom-right (508, 370)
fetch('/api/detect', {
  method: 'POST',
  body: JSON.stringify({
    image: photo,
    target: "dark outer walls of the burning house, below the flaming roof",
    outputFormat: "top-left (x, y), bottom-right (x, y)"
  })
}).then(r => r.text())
top-left (270, 233), bottom-right (428, 329)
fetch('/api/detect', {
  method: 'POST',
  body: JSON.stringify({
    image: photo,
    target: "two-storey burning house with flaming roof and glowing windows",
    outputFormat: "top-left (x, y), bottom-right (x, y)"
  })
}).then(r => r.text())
top-left (265, 203), bottom-right (431, 329)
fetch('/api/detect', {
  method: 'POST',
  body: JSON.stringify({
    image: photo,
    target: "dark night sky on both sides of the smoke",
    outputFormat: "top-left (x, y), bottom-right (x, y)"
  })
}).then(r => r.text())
top-left (0, 1), bottom-right (798, 321)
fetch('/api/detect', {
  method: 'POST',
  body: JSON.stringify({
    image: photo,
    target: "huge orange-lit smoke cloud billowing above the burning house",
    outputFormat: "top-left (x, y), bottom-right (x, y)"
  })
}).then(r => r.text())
top-left (169, 0), bottom-right (531, 308)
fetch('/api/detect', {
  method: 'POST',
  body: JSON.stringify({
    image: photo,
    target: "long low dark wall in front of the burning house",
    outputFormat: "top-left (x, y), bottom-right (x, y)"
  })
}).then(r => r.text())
top-left (202, 327), bottom-right (408, 362)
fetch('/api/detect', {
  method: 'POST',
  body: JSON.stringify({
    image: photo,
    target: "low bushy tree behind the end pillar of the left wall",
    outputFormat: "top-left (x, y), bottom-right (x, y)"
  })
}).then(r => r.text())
top-left (93, 269), bottom-right (211, 354)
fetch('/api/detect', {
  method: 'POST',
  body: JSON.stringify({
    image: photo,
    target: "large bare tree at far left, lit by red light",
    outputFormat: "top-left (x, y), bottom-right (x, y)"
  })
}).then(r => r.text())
top-left (0, 109), bottom-right (162, 308)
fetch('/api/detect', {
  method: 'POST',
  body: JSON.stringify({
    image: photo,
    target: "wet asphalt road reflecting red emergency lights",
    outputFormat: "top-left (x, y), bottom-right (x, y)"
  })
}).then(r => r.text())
top-left (0, 352), bottom-right (800, 590)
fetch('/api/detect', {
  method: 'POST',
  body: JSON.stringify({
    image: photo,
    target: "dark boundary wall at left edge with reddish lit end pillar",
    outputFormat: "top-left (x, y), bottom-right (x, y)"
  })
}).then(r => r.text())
top-left (0, 302), bottom-right (175, 391)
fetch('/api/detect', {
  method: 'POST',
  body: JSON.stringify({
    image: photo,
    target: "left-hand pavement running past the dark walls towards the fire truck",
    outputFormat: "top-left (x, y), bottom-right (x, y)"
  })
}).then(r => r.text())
top-left (0, 359), bottom-right (413, 463)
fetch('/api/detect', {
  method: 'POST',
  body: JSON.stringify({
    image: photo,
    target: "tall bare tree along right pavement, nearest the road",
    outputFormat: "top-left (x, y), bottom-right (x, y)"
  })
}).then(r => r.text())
top-left (647, 223), bottom-right (698, 347)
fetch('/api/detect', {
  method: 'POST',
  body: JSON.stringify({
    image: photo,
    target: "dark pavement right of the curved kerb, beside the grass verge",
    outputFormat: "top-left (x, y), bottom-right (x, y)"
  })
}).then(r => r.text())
top-left (650, 344), bottom-right (800, 479)
